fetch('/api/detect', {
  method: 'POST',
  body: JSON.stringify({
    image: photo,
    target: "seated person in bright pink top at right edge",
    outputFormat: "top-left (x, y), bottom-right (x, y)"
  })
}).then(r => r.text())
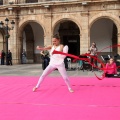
top-left (105, 58), bottom-right (117, 77)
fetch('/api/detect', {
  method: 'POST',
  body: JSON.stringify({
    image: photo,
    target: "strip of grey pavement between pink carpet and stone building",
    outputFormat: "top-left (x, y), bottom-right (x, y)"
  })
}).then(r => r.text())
top-left (0, 64), bottom-right (100, 77)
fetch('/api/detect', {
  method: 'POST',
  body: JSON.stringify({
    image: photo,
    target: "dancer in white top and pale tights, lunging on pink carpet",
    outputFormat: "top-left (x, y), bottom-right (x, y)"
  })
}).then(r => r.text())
top-left (33, 35), bottom-right (74, 92)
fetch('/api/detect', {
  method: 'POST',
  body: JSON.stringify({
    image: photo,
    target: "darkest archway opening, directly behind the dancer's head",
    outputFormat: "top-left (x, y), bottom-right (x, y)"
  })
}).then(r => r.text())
top-left (53, 20), bottom-right (80, 55)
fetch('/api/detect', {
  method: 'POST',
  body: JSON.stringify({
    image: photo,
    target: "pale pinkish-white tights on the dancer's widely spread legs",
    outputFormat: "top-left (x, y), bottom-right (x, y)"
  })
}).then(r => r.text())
top-left (36, 63), bottom-right (71, 89)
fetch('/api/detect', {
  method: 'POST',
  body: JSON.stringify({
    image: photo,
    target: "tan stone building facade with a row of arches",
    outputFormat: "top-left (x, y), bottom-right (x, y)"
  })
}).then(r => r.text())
top-left (0, 0), bottom-right (120, 64)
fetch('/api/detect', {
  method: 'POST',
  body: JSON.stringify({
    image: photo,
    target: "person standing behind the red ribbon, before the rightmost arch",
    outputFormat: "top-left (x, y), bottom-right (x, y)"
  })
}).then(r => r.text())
top-left (90, 42), bottom-right (98, 70)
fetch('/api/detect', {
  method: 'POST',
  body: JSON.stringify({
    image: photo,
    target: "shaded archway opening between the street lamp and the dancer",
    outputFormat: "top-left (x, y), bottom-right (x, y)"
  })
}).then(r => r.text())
top-left (21, 22), bottom-right (44, 63)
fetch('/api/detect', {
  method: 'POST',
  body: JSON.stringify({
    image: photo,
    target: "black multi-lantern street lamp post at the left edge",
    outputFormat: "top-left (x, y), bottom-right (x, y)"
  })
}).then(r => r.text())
top-left (0, 18), bottom-right (15, 65)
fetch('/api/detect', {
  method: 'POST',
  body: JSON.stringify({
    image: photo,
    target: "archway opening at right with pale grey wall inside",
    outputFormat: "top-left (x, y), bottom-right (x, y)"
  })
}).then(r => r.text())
top-left (90, 18), bottom-right (118, 56)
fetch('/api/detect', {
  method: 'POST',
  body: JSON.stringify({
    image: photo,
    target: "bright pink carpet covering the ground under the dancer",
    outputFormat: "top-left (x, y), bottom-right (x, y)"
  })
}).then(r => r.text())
top-left (0, 76), bottom-right (120, 120)
